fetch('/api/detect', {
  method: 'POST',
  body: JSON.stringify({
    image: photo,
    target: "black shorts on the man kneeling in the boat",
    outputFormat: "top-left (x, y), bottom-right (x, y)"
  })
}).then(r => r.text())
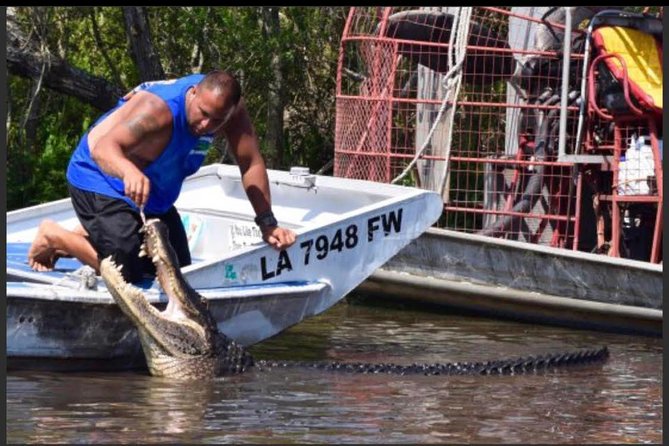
top-left (68, 184), bottom-right (191, 282)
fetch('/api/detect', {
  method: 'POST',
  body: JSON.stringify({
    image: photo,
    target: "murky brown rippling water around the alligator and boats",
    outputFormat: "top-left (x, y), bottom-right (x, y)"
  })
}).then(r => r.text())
top-left (7, 303), bottom-right (662, 444)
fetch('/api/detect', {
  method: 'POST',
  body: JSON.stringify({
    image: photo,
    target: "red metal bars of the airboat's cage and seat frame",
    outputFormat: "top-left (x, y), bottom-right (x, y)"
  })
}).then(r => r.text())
top-left (335, 7), bottom-right (663, 263)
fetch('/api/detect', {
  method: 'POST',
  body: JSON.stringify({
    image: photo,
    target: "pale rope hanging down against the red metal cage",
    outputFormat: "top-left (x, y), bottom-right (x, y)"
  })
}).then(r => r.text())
top-left (391, 8), bottom-right (472, 186)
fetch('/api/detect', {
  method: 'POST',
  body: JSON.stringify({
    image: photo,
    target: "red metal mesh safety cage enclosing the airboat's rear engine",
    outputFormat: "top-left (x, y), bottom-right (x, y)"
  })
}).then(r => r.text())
top-left (334, 7), bottom-right (661, 261)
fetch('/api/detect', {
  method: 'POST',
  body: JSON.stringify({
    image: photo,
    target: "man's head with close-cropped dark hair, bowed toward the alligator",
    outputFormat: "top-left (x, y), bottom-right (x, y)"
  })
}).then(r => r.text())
top-left (186, 71), bottom-right (242, 135)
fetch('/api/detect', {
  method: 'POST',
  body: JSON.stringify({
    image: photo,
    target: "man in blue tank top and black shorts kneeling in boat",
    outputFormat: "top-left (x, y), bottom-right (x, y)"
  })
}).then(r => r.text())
top-left (28, 71), bottom-right (295, 282)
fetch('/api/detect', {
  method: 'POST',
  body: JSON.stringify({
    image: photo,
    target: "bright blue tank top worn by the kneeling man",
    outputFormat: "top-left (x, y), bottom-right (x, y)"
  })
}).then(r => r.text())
top-left (67, 74), bottom-right (213, 214)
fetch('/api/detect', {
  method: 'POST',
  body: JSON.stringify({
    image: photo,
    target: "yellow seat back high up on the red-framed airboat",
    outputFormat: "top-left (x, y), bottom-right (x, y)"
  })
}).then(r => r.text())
top-left (592, 26), bottom-right (663, 116)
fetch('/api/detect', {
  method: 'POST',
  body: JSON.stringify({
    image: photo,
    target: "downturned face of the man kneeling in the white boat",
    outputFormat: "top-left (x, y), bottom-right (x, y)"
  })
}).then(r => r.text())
top-left (186, 86), bottom-right (235, 136)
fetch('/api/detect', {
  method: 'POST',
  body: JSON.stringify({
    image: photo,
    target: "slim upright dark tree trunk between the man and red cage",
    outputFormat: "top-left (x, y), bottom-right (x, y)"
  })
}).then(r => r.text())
top-left (262, 6), bottom-right (285, 167)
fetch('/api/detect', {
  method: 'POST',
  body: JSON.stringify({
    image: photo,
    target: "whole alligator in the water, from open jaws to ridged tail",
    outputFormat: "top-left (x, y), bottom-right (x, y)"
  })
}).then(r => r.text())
top-left (100, 219), bottom-right (609, 379)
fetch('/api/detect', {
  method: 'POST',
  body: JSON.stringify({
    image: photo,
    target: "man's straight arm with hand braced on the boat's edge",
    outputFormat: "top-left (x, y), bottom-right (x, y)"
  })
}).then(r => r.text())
top-left (222, 99), bottom-right (295, 249)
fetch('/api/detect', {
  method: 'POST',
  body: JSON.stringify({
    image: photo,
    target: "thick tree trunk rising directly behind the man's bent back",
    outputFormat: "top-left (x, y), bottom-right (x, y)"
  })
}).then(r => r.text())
top-left (123, 6), bottom-right (165, 82)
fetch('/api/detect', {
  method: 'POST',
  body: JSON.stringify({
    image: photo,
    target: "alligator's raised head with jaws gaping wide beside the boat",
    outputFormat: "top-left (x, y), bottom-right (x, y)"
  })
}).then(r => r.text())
top-left (100, 219), bottom-right (252, 378)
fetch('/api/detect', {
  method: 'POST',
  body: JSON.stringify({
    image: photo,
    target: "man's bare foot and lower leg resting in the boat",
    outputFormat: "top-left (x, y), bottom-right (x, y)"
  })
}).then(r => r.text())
top-left (28, 219), bottom-right (100, 271)
